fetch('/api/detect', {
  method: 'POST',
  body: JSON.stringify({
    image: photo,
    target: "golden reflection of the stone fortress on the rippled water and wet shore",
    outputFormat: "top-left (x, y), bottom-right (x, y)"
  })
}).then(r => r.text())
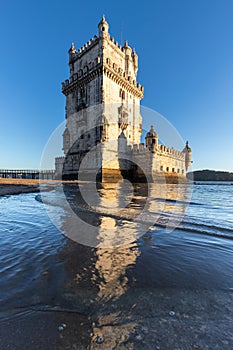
top-left (56, 183), bottom-right (191, 349)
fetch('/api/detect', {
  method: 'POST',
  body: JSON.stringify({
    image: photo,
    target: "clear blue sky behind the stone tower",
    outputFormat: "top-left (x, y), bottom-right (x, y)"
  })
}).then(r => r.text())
top-left (0, 0), bottom-right (233, 171)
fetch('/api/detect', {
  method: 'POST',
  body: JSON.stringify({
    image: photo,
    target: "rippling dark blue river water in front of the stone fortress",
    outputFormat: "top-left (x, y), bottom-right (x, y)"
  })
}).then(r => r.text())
top-left (0, 183), bottom-right (233, 350)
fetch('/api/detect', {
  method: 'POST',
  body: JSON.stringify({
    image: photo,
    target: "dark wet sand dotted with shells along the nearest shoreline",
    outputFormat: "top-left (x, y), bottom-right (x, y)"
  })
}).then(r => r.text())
top-left (0, 290), bottom-right (233, 350)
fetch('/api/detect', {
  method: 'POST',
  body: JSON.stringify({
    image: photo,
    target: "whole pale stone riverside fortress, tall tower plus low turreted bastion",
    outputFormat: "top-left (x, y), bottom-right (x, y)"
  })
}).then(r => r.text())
top-left (55, 17), bottom-right (191, 179)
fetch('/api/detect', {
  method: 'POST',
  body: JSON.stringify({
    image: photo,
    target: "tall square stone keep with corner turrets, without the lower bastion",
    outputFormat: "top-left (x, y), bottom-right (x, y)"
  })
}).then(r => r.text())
top-left (56, 16), bottom-right (144, 179)
